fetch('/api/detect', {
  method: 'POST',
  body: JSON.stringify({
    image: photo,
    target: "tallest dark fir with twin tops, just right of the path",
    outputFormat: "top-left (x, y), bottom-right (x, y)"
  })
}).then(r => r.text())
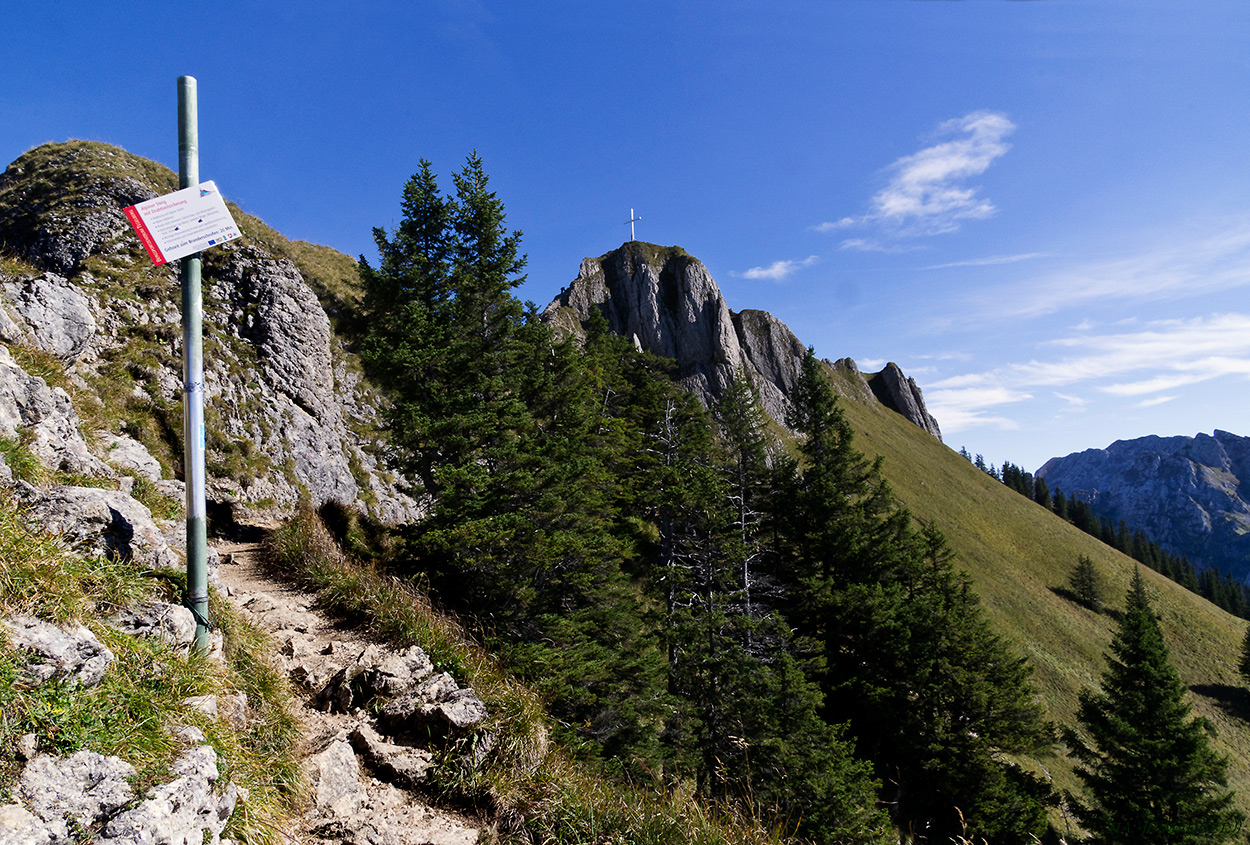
top-left (360, 155), bottom-right (665, 775)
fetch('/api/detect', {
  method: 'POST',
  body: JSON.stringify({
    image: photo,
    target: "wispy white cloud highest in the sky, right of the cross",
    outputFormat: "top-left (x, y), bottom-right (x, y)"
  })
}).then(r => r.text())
top-left (813, 111), bottom-right (1015, 243)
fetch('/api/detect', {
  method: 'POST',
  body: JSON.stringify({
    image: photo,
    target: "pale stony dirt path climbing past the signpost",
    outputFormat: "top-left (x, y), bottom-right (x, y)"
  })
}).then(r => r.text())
top-left (215, 541), bottom-right (479, 845)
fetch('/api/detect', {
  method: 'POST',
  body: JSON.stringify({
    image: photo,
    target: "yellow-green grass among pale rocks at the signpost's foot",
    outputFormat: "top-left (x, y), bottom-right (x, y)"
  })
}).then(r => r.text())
top-left (0, 494), bottom-right (304, 845)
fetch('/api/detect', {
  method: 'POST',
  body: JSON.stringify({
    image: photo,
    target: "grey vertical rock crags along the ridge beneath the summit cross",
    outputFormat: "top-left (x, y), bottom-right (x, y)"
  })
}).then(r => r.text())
top-left (543, 241), bottom-right (941, 439)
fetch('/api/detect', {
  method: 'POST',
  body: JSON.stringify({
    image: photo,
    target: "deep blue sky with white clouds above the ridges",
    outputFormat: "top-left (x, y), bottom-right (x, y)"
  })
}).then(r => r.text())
top-left (0, 0), bottom-right (1250, 470)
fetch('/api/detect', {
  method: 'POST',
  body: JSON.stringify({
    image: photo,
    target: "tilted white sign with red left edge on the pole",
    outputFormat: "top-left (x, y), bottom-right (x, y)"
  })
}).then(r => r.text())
top-left (124, 183), bottom-right (241, 264)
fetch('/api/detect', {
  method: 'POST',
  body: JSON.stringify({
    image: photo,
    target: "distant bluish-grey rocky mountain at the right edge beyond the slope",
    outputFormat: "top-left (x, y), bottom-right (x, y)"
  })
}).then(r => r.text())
top-left (1035, 430), bottom-right (1250, 580)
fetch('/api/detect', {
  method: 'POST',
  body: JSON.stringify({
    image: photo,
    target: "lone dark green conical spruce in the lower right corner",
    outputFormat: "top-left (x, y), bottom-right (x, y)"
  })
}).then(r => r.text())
top-left (1064, 569), bottom-right (1243, 845)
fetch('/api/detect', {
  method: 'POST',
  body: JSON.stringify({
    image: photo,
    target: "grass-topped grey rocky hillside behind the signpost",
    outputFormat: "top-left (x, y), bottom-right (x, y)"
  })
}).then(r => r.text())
top-left (0, 141), bottom-right (421, 521)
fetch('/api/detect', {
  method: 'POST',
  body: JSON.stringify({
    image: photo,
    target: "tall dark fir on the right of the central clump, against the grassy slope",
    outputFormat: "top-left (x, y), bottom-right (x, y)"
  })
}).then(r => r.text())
top-left (773, 353), bottom-right (1049, 843)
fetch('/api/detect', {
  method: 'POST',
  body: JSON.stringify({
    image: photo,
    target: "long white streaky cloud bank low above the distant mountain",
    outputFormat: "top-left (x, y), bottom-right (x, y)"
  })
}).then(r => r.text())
top-left (925, 314), bottom-right (1250, 433)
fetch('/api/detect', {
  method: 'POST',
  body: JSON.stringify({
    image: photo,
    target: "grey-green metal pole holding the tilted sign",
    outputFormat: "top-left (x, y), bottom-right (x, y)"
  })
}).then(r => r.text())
top-left (178, 76), bottom-right (209, 653)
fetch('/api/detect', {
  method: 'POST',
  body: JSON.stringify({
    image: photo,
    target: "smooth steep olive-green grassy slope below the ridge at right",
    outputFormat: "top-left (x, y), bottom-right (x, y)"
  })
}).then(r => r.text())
top-left (841, 367), bottom-right (1250, 811)
